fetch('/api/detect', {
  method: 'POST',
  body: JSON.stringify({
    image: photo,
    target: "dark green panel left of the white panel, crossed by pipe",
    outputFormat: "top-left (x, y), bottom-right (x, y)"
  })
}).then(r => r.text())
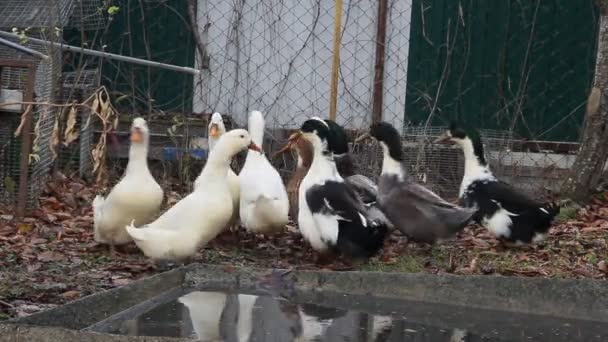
top-left (103, 0), bottom-right (195, 112)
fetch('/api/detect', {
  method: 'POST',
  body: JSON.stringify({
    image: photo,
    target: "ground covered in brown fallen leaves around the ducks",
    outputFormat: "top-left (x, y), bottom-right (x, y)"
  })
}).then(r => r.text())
top-left (0, 174), bottom-right (608, 319)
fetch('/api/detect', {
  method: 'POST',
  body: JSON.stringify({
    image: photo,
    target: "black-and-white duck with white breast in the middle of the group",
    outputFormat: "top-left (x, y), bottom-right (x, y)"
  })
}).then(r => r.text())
top-left (296, 118), bottom-right (387, 258)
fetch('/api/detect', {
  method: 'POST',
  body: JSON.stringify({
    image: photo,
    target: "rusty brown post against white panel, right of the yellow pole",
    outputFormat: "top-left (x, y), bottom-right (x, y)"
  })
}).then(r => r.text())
top-left (372, 0), bottom-right (388, 123)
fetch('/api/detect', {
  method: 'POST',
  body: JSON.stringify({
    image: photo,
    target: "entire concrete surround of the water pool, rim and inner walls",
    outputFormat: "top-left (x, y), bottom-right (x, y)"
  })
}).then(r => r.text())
top-left (0, 264), bottom-right (608, 342)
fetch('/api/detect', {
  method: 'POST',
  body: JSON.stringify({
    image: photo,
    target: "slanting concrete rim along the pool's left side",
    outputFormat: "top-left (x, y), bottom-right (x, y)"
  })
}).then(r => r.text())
top-left (5, 267), bottom-right (187, 330)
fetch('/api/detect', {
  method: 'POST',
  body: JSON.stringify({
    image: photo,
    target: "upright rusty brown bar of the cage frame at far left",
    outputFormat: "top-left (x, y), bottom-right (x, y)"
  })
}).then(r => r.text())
top-left (15, 62), bottom-right (36, 220)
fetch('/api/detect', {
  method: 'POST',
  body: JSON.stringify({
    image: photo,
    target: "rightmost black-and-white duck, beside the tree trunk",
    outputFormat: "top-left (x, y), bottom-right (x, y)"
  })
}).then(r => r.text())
top-left (435, 124), bottom-right (559, 244)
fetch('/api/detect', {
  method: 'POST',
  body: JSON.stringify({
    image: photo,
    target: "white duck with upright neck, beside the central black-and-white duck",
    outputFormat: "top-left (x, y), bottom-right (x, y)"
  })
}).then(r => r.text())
top-left (239, 111), bottom-right (289, 234)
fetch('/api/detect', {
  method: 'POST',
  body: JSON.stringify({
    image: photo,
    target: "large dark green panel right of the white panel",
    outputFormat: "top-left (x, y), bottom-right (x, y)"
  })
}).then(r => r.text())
top-left (406, 0), bottom-right (598, 141)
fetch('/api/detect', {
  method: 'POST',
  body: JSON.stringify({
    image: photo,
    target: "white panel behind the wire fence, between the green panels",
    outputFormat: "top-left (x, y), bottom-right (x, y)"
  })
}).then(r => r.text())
top-left (194, 0), bottom-right (411, 128)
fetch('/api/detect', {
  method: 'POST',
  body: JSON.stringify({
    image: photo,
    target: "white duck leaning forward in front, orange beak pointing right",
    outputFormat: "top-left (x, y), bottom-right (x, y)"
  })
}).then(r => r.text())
top-left (127, 129), bottom-right (261, 262)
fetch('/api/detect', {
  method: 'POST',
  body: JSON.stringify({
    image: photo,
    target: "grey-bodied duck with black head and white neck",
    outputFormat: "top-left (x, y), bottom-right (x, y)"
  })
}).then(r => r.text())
top-left (357, 122), bottom-right (476, 243)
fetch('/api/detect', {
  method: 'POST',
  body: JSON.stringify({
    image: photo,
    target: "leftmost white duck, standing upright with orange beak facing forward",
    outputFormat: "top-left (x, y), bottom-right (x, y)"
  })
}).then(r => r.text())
top-left (93, 118), bottom-right (163, 253)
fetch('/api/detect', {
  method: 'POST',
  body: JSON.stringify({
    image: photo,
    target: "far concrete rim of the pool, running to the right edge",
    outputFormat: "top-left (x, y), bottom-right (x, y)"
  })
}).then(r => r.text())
top-left (185, 265), bottom-right (608, 322)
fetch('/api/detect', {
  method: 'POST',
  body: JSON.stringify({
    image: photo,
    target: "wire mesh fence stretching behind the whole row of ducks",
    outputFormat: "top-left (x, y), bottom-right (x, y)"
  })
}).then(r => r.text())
top-left (0, 0), bottom-right (598, 212)
